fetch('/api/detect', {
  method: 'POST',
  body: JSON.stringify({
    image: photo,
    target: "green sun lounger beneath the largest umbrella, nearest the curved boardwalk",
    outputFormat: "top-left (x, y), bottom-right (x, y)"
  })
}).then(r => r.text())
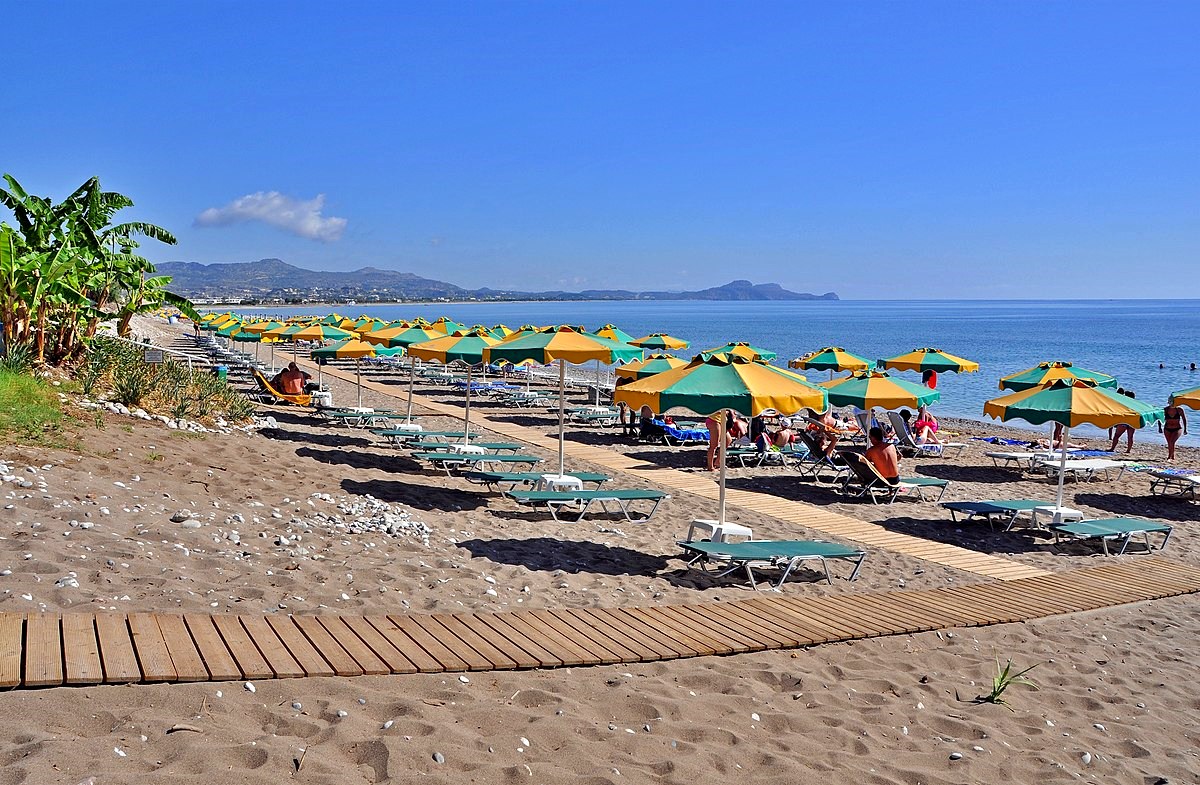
top-left (679, 540), bottom-right (866, 592)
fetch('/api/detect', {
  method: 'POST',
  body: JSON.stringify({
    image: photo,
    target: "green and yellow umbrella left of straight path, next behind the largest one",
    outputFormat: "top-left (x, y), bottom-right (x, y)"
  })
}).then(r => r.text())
top-left (485, 325), bottom-right (642, 475)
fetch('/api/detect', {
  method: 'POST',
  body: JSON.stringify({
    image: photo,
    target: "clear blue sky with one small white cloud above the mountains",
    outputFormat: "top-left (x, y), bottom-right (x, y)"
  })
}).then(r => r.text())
top-left (0, 1), bottom-right (1200, 299)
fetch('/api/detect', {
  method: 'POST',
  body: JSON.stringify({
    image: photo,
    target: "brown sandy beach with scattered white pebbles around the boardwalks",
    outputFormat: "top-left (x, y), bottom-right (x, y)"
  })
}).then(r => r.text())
top-left (0, 324), bottom-right (1200, 785)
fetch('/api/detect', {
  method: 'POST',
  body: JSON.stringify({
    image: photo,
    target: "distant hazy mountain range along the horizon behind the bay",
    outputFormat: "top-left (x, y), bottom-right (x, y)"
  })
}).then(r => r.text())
top-left (156, 259), bottom-right (838, 302)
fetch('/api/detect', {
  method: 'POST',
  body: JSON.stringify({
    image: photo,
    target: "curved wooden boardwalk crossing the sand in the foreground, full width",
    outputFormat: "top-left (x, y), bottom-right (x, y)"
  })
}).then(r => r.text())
top-left (0, 557), bottom-right (1200, 688)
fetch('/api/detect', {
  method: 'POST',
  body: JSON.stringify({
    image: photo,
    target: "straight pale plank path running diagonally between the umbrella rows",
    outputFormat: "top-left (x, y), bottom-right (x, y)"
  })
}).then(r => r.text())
top-left (324, 367), bottom-right (1050, 581)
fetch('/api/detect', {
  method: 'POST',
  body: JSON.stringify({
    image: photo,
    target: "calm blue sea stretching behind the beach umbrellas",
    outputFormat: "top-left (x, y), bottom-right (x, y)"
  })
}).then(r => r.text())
top-left (231, 300), bottom-right (1200, 445)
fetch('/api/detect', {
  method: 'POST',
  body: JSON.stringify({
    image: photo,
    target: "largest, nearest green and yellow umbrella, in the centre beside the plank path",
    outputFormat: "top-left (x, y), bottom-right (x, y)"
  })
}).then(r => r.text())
top-left (613, 352), bottom-right (828, 523)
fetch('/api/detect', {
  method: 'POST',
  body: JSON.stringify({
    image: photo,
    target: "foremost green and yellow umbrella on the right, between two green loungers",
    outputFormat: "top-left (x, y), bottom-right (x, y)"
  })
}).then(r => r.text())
top-left (983, 379), bottom-right (1164, 520)
